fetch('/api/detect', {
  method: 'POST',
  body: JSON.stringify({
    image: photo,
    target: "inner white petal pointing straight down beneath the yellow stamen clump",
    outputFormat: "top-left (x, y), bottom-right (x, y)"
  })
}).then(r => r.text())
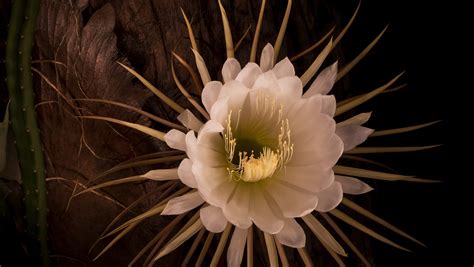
top-left (250, 186), bottom-right (284, 234)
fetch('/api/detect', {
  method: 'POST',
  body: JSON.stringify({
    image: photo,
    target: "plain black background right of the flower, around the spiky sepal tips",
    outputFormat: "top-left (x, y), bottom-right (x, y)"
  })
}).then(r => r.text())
top-left (342, 0), bottom-right (468, 266)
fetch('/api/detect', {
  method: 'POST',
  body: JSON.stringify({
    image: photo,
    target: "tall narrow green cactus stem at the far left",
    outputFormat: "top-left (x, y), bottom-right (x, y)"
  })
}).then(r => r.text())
top-left (6, 0), bottom-right (49, 266)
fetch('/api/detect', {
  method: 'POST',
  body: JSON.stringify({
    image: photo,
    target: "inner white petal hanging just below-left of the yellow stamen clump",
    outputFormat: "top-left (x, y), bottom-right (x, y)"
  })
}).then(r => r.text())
top-left (222, 183), bottom-right (252, 228)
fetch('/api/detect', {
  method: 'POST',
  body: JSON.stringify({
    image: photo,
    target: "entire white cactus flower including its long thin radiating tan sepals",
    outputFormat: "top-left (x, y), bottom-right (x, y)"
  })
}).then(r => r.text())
top-left (81, 1), bottom-right (436, 266)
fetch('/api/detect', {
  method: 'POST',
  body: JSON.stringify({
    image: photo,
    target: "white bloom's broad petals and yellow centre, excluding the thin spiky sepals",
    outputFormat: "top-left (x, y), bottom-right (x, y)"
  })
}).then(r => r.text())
top-left (162, 44), bottom-right (372, 251)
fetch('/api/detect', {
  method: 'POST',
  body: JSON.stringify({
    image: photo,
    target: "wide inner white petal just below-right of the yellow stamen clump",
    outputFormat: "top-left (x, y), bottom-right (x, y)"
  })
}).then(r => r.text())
top-left (265, 178), bottom-right (318, 218)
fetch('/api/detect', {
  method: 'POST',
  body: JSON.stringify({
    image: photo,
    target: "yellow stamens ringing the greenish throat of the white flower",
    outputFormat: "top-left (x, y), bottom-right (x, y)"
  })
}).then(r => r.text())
top-left (224, 97), bottom-right (293, 182)
